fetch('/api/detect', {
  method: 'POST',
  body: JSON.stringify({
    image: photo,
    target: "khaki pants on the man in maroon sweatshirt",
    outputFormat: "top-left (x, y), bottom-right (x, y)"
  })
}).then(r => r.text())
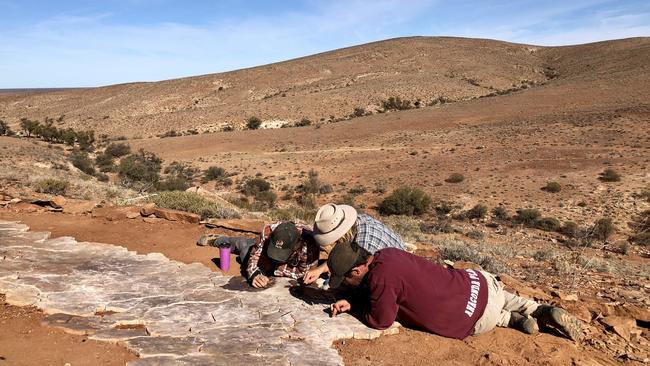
top-left (474, 271), bottom-right (539, 335)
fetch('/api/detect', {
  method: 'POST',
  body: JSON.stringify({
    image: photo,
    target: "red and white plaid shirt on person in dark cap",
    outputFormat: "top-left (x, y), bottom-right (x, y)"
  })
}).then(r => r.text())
top-left (246, 222), bottom-right (319, 280)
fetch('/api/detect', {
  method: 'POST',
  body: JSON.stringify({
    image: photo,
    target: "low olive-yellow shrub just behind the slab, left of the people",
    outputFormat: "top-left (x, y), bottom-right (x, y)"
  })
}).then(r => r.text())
top-left (150, 191), bottom-right (240, 219)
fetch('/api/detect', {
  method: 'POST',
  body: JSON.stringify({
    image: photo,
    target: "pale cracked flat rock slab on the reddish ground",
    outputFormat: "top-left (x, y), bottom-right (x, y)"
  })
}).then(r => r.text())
top-left (0, 221), bottom-right (396, 366)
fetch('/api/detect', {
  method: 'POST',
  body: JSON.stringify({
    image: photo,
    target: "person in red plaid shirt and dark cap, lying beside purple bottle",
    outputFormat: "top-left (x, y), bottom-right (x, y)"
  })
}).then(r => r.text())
top-left (197, 222), bottom-right (320, 288)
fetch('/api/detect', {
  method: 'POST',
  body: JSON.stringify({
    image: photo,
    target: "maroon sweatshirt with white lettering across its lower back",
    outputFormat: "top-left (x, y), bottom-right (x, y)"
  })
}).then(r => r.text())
top-left (363, 248), bottom-right (487, 339)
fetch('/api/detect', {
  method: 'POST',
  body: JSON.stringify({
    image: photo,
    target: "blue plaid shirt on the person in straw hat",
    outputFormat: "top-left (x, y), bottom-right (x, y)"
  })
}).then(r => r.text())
top-left (354, 214), bottom-right (406, 254)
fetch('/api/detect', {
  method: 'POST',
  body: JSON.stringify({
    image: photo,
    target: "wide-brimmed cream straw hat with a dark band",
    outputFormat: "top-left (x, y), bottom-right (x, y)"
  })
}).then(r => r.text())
top-left (314, 203), bottom-right (357, 245)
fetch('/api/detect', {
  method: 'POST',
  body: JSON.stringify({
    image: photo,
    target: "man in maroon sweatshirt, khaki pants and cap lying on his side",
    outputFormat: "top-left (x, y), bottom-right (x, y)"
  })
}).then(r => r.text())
top-left (327, 243), bottom-right (582, 341)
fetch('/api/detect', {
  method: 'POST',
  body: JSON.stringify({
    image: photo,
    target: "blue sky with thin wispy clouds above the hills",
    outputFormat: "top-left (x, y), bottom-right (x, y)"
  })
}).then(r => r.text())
top-left (0, 0), bottom-right (650, 88)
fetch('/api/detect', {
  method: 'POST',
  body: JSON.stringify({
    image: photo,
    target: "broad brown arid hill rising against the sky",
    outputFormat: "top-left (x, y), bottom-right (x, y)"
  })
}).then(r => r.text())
top-left (0, 37), bottom-right (650, 137)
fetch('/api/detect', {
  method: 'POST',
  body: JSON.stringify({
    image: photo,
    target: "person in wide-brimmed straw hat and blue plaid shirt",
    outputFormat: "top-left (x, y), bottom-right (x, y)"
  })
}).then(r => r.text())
top-left (303, 203), bottom-right (406, 284)
